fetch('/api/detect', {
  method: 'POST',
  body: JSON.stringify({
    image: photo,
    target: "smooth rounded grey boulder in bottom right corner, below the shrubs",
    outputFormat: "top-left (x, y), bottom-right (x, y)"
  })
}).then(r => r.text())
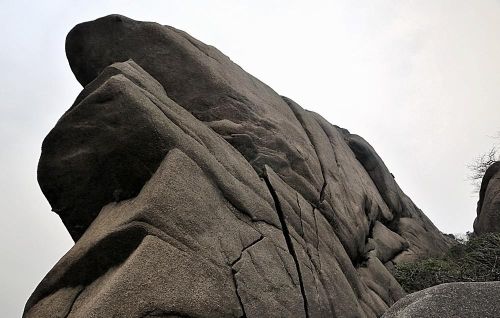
top-left (382, 282), bottom-right (500, 318)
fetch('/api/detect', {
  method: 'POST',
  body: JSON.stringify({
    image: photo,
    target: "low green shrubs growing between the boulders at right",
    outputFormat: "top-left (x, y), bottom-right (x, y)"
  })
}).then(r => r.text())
top-left (394, 233), bottom-right (500, 293)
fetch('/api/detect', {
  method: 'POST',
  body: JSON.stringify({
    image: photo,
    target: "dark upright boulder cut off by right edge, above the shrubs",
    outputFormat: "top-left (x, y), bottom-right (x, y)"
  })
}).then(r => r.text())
top-left (474, 162), bottom-right (500, 235)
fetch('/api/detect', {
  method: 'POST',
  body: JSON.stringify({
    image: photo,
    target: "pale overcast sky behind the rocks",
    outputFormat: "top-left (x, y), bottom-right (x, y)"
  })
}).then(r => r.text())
top-left (0, 0), bottom-right (500, 317)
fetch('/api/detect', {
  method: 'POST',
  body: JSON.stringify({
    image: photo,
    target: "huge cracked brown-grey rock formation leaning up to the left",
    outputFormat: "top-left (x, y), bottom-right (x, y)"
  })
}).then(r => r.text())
top-left (24, 15), bottom-right (450, 317)
